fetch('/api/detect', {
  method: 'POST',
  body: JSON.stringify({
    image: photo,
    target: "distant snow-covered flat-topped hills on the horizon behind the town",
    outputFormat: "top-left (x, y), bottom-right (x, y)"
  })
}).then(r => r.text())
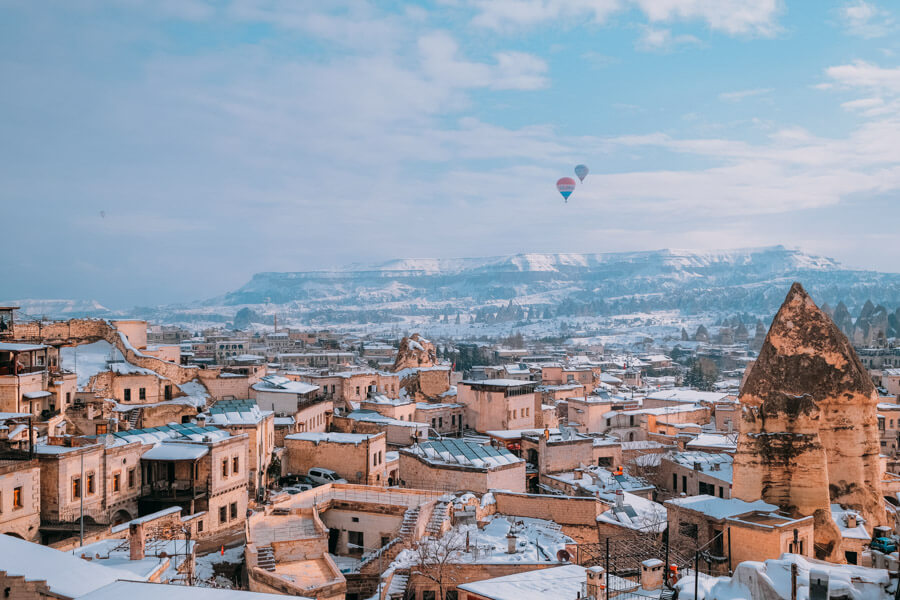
top-left (12, 246), bottom-right (900, 329)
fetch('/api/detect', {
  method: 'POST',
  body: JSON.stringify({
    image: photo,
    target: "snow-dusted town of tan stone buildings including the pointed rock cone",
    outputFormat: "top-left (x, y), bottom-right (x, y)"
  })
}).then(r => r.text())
top-left (0, 283), bottom-right (900, 600)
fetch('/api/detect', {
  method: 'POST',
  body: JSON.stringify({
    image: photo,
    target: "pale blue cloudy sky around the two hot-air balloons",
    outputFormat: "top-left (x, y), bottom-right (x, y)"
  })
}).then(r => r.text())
top-left (0, 0), bottom-right (900, 307)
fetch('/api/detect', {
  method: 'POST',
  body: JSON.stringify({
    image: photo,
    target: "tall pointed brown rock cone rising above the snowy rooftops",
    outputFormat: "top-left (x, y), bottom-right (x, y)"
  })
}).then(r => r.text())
top-left (732, 283), bottom-right (885, 559)
